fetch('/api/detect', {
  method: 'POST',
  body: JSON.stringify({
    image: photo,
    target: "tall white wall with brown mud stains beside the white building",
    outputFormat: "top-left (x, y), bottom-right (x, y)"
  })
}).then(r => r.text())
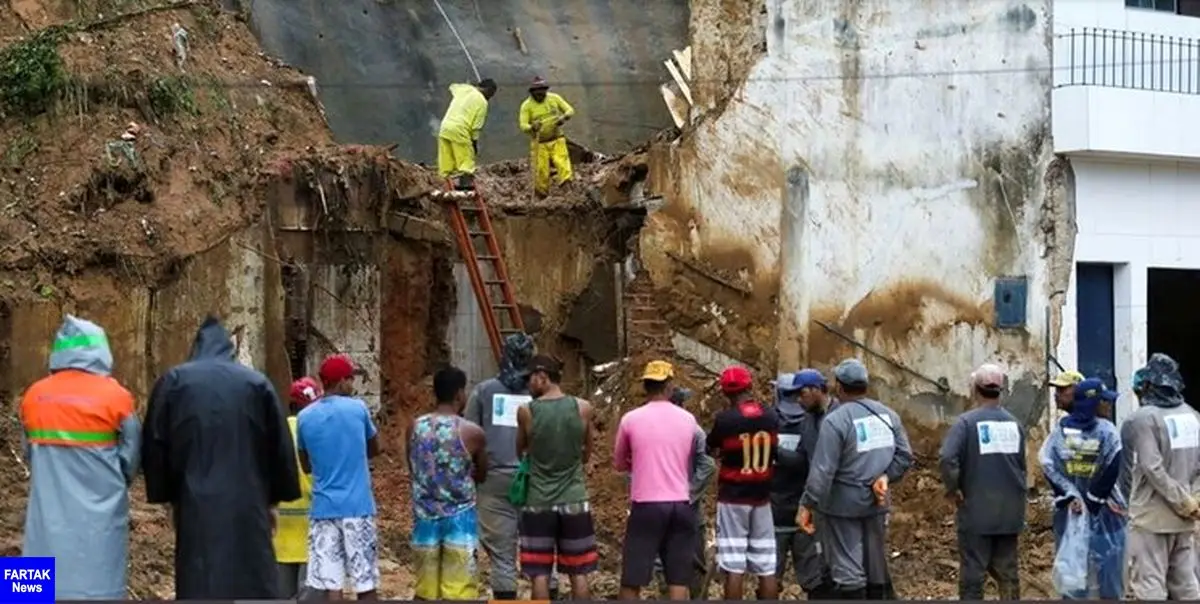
top-left (642, 0), bottom-right (1069, 419)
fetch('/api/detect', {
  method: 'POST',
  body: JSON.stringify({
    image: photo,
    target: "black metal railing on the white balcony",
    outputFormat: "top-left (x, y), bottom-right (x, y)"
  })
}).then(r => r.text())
top-left (1055, 28), bottom-right (1200, 95)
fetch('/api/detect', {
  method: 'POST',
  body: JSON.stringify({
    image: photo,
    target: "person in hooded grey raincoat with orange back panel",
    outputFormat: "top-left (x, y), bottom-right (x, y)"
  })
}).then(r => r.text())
top-left (20, 315), bottom-right (140, 600)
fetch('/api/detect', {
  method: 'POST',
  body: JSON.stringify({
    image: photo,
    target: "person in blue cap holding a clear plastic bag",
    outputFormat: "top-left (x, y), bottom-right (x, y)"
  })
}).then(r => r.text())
top-left (1038, 377), bottom-right (1124, 599)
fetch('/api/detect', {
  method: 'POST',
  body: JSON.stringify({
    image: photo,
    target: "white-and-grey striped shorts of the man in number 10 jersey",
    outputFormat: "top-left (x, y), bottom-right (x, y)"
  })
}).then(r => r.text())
top-left (716, 502), bottom-right (775, 576)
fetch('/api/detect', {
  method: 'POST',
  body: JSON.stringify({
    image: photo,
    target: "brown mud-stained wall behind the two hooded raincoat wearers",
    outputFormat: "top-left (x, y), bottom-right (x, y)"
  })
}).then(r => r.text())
top-left (0, 227), bottom-right (288, 405)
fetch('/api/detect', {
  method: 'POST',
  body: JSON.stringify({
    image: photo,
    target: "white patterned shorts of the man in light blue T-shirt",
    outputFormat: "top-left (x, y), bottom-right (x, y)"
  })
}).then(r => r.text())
top-left (305, 516), bottom-right (379, 593)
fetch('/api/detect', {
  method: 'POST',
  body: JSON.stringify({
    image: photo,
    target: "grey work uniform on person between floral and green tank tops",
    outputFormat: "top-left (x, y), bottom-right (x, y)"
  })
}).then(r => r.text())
top-left (463, 377), bottom-right (557, 594)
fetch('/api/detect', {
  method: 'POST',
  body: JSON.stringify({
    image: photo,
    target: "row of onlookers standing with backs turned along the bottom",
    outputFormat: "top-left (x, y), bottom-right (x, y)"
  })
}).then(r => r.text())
top-left (20, 316), bottom-right (1200, 599)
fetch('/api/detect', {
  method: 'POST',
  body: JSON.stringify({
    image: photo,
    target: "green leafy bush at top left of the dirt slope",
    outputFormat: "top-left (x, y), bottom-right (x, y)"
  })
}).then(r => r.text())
top-left (0, 31), bottom-right (67, 116)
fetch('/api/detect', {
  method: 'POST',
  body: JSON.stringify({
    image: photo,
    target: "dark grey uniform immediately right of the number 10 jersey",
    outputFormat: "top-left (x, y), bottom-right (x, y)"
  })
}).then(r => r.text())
top-left (770, 403), bottom-right (826, 598)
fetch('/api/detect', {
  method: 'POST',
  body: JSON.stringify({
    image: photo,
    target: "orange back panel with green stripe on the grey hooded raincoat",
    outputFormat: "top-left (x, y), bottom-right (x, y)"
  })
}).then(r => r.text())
top-left (20, 371), bottom-right (133, 447)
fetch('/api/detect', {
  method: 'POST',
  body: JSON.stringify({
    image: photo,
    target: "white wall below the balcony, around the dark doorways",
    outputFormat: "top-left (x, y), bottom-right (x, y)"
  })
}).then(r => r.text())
top-left (1057, 160), bottom-right (1200, 418)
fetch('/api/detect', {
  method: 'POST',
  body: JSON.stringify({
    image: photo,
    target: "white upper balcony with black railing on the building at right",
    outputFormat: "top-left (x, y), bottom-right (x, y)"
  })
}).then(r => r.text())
top-left (1054, 0), bottom-right (1200, 159)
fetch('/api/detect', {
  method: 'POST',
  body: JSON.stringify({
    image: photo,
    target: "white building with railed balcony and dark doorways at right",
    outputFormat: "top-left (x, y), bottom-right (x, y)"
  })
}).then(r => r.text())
top-left (1051, 0), bottom-right (1200, 419)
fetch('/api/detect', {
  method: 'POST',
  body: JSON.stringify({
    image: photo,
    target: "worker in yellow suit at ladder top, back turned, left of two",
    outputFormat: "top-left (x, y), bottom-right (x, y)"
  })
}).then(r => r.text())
top-left (438, 79), bottom-right (496, 190)
